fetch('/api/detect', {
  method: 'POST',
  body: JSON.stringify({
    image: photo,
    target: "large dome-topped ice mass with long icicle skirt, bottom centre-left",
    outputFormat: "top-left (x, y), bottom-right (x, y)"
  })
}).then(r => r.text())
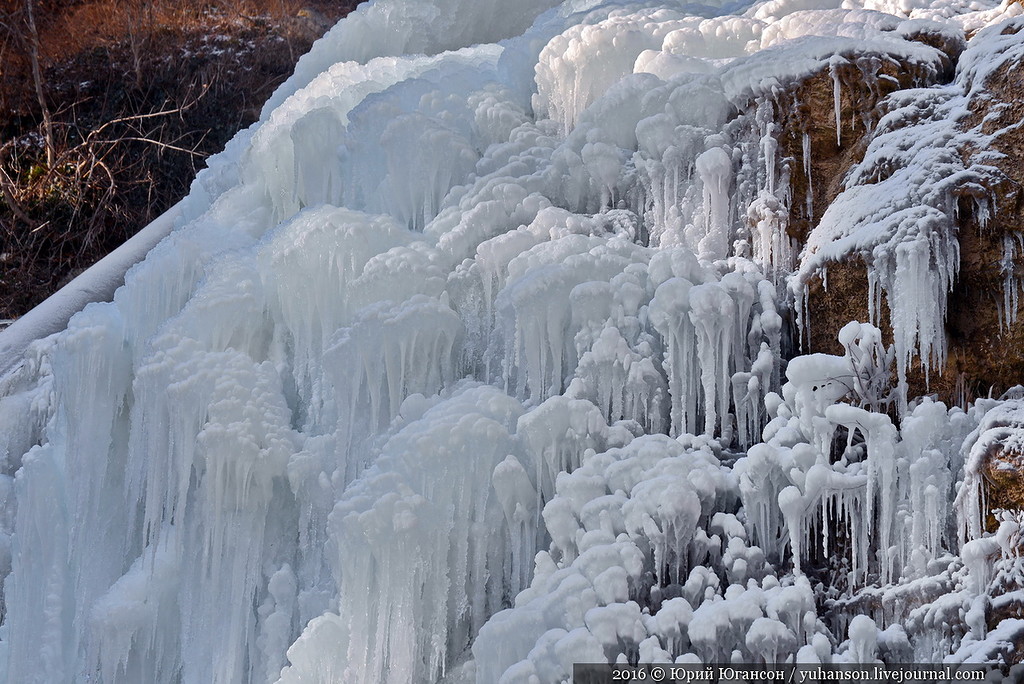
top-left (313, 386), bottom-right (528, 682)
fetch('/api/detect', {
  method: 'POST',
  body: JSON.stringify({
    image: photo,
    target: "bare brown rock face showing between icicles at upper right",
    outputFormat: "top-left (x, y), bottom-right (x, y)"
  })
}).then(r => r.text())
top-left (782, 24), bottom-right (1024, 405)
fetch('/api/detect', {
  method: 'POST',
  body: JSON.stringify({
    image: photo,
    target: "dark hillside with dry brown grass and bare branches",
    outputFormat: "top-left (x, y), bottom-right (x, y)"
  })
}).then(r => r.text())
top-left (0, 0), bottom-right (355, 318)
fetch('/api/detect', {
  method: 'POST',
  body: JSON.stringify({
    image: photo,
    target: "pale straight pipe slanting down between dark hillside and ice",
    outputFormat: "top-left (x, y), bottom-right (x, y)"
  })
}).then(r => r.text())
top-left (0, 197), bottom-right (181, 378)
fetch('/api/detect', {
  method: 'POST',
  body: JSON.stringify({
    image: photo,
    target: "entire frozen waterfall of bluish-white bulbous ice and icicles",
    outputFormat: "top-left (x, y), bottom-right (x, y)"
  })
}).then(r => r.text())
top-left (0, 0), bottom-right (1024, 684)
